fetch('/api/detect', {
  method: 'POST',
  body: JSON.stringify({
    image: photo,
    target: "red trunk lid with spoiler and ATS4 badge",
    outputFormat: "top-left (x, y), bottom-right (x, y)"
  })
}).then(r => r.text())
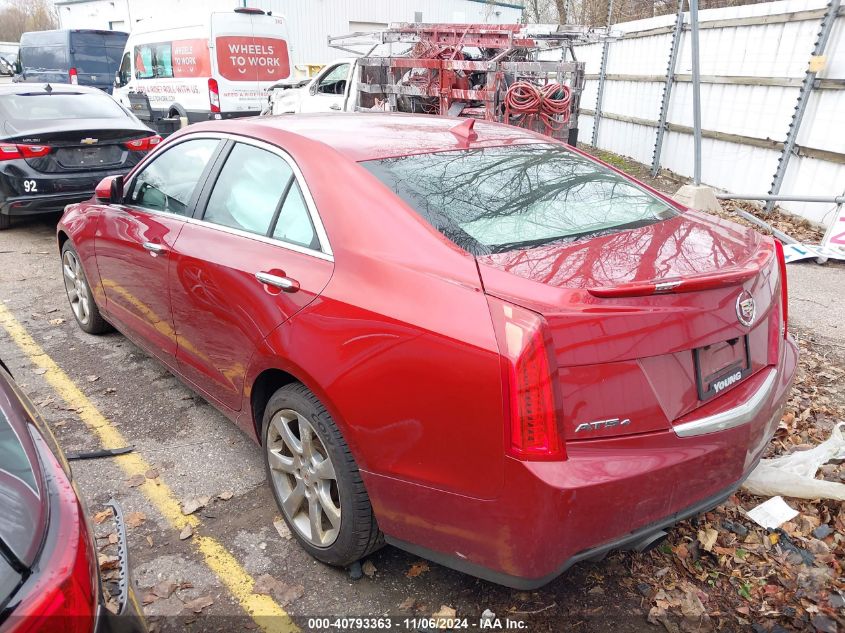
top-left (477, 212), bottom-right (779, 441)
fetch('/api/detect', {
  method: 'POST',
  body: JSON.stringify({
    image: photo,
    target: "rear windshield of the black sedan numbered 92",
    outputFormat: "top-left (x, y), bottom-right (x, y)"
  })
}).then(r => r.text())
top-left (0, 92), bottom-right (127, 121)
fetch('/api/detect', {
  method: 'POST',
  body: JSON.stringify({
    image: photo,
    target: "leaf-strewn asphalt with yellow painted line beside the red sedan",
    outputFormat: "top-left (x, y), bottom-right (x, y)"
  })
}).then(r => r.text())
top-left (0, 216), bottom-right (653, 633)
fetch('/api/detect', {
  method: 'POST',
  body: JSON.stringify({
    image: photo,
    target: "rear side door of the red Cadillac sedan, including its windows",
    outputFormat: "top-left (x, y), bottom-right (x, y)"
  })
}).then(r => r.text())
top-left (170, 141), bottom-right (334, 410)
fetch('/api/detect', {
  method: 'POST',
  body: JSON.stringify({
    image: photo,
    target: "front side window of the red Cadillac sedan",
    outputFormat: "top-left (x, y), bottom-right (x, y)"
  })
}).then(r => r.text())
top-left (126, 138), bottom-right (218, 215)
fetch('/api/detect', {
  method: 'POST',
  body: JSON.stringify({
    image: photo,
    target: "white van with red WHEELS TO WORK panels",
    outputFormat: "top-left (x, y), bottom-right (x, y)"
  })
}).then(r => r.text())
top-left (114, 8), bottom-right (290, 123)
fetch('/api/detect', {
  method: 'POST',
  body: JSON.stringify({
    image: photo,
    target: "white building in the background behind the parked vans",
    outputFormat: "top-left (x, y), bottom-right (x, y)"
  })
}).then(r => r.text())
top-left (55, 0), bottom-right (522, 64)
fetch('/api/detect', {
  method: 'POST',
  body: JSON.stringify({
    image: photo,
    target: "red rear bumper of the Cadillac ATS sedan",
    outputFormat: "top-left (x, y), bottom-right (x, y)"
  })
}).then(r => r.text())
top-left (364, 339), bottom-right (797, 589)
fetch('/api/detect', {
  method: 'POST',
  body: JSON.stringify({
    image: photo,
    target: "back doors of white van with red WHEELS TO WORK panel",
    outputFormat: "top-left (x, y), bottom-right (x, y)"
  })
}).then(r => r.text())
top-left (211, 10), bottom-right (290, 114)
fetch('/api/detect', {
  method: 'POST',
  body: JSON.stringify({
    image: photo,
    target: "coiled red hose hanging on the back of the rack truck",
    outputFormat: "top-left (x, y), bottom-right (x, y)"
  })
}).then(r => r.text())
top-left (505, 81), bottom-right (572, 135)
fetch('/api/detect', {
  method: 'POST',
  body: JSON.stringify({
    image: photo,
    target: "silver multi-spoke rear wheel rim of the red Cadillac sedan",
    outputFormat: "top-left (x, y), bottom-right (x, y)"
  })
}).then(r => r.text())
top-left (266, 409), bottom-right (341, 547)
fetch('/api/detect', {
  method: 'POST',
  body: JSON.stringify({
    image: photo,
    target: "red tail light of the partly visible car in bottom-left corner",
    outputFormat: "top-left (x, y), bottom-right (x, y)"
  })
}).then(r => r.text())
top-left (9, 450), bottom-right (99, 633)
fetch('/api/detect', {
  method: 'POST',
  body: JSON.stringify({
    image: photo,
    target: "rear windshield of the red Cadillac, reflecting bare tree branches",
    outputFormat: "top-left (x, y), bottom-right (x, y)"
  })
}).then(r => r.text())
top-left (361, 144), bottom-right (677, 255)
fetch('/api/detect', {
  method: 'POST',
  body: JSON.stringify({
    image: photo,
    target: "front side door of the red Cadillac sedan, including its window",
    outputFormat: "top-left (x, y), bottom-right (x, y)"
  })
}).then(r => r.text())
top-left (95, 138), bottom-right (221, 362)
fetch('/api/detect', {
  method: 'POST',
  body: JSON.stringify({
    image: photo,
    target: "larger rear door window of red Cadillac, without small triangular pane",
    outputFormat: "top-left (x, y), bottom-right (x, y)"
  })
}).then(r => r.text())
top-left (203, 143), bottom-right (293, 235)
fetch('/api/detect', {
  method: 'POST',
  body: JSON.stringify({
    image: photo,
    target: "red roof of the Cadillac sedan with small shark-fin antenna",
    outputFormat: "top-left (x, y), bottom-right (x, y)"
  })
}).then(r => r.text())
top-left (210, 112), bottom-right (556, 162)
